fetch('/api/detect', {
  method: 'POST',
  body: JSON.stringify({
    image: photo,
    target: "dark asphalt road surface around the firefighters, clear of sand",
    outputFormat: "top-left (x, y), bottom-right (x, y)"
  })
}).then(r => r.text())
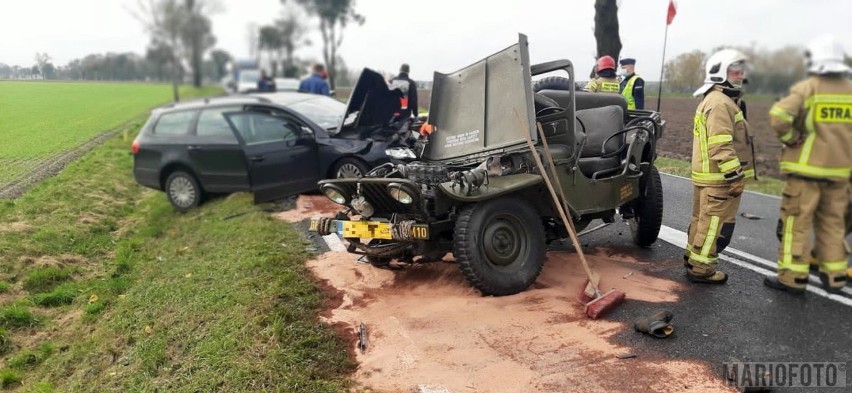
top-left (582, 175), bottom-right (852, 392)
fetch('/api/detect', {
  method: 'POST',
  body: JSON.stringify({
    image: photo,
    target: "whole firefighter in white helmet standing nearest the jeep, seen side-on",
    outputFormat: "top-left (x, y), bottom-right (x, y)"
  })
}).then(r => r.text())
top-left (684, 49), bottom-right (754, 284)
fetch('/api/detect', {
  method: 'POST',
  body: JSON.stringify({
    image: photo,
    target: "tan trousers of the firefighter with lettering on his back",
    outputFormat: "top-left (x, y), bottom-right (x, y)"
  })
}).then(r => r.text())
top-left (778, 176), bottom-right (850, 288)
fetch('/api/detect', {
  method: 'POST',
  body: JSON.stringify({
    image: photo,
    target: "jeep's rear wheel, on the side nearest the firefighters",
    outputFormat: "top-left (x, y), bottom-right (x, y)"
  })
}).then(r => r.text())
top-left (629, 165), bottom-right (663, 247)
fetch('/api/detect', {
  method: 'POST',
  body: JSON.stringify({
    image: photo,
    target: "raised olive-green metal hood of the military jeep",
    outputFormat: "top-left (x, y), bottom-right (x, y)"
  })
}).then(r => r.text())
top-left (423, 34), bottom-right (537, 161)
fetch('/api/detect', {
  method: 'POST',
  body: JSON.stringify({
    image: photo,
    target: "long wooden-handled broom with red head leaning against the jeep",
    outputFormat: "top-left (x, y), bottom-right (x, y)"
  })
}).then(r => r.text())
top-left (515, 112), bottom-right (625, 319)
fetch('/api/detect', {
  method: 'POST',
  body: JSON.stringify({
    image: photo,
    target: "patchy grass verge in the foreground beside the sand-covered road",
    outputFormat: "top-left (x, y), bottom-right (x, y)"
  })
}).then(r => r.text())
top-left (0, 91), bottom-right (354, 392)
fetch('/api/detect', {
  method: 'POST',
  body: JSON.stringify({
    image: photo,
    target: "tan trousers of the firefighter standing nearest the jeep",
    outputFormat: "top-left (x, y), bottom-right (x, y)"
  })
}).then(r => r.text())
top-left (685, 185), bottom-right (740, 276)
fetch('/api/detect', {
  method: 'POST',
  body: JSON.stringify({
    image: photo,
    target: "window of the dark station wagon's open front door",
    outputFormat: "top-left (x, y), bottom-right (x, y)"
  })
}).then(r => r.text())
top-left (227, 112), bottom-right (301, 145)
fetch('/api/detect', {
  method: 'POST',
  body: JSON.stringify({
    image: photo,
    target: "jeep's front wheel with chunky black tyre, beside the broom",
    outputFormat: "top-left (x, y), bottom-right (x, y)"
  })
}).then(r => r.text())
top-left (453, 198), bottom-right (544, 296)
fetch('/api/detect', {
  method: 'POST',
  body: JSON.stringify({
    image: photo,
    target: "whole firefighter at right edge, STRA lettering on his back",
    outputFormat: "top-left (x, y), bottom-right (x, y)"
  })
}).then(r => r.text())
top-left (764, 36), bottom-right (852, 293)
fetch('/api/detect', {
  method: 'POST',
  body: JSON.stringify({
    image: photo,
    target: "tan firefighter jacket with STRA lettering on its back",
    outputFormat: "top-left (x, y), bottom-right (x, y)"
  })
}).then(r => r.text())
top-left (769, 76), bottom-right (852, 181)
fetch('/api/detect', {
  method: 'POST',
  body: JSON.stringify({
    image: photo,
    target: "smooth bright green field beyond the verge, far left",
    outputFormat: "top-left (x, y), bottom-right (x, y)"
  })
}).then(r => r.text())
top-left (0, 81), bottom-right (221, 185)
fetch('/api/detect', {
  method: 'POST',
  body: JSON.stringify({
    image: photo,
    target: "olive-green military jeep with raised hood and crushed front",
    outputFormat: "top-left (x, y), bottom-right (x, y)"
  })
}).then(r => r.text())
top-left (310, 35), bottom-right (664, 296)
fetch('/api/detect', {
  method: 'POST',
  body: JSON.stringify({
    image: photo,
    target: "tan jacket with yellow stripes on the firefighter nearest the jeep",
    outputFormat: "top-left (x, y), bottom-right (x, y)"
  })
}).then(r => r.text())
top-left (692, 86), bottom-right (754, 186)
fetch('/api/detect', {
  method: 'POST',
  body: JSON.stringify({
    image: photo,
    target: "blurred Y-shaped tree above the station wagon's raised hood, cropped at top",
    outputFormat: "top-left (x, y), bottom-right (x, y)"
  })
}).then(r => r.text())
top-left (281, 0), bottom-right (364, 90)
